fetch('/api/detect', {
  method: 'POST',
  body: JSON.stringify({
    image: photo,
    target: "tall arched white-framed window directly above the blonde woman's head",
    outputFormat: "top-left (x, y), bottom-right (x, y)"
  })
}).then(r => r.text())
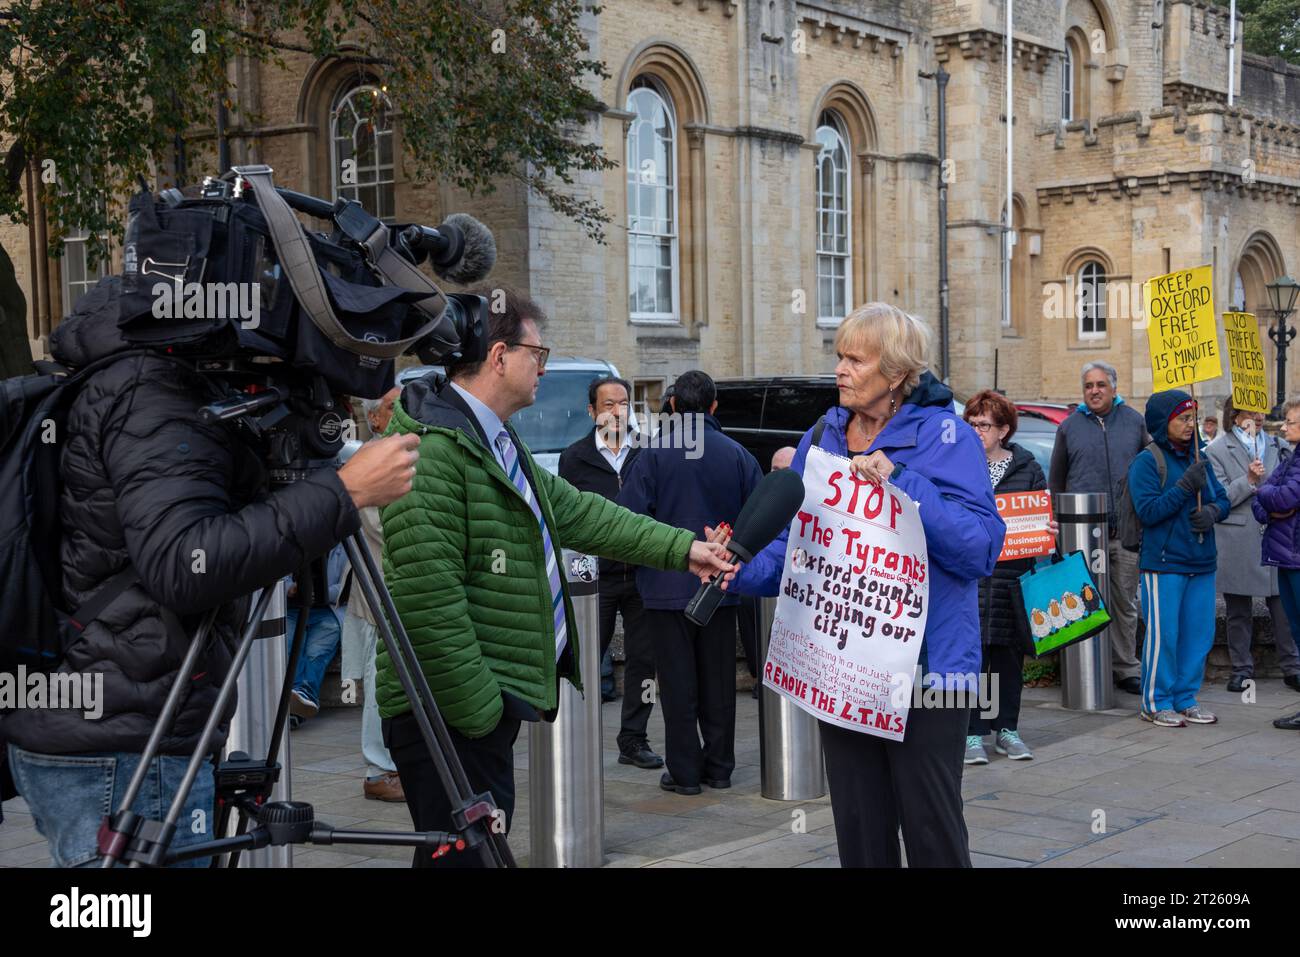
top-left (816, 111), bottom-right (853, 324)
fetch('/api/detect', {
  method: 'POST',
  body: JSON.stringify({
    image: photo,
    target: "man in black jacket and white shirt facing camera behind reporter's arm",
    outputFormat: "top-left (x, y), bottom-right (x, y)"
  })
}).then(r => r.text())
top-left (560, 376), bottom-right (663, 768)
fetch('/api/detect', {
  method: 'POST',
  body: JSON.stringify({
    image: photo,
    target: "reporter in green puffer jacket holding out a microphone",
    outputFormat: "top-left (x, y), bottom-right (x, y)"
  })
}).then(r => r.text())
top-left (376, 290), bottom-right (732, 867)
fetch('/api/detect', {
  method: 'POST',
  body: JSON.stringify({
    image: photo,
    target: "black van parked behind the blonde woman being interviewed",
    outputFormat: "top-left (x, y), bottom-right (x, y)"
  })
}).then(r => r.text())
top-left (718, 376), bottom-right (840, 472)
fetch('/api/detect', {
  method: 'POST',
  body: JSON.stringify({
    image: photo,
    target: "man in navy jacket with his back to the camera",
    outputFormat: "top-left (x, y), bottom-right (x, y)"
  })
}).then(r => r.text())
top-left (619, 371), bottom-right (763, 794)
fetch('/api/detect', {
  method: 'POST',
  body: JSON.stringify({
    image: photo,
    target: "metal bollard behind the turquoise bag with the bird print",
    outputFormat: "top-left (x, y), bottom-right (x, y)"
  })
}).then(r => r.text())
top-left (1053, 492), bottom-right (1115, 711)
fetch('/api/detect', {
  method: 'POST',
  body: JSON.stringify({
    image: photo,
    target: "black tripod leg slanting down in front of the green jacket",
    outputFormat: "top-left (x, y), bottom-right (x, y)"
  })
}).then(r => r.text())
top-left (343, 532), bottom-right (515, 867)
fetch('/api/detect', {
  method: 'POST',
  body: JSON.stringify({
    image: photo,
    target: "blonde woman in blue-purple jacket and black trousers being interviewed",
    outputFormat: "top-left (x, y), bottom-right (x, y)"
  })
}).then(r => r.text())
top-left (731, 303), bottom-right (1006, 867)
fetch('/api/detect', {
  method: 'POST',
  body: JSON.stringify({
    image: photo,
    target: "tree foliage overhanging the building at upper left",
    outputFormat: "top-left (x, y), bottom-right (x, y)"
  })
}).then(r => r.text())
top-left (0, 0), bottom-right (614, 261)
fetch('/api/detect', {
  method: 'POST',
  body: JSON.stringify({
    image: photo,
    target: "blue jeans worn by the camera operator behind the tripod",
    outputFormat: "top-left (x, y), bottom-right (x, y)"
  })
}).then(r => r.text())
top-left (9, 745), bottom-right (216, 867)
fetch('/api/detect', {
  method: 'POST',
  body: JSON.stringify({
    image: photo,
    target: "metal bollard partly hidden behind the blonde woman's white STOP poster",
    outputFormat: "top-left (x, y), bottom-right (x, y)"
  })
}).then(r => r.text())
top-left (758, 598), bottom-right (826, 801)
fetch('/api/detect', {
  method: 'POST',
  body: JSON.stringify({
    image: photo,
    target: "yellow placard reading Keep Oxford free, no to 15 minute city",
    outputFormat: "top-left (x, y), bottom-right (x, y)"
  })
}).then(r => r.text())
top-left (1144, 265), bottom-right (1223, 393)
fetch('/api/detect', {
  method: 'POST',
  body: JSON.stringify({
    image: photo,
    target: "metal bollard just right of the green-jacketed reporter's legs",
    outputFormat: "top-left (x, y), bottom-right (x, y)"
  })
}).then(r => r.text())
top-left (528, 549), bottom-right (605, 867)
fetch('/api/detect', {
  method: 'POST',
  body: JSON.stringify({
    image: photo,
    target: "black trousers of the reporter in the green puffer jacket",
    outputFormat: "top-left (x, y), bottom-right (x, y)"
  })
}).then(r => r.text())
top-left (384, 713), bottom-right (520, 867)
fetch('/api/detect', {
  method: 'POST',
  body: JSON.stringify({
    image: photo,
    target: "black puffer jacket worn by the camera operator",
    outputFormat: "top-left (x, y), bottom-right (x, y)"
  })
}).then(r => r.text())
top-left (0, 280), bottom-right (360, 754)
